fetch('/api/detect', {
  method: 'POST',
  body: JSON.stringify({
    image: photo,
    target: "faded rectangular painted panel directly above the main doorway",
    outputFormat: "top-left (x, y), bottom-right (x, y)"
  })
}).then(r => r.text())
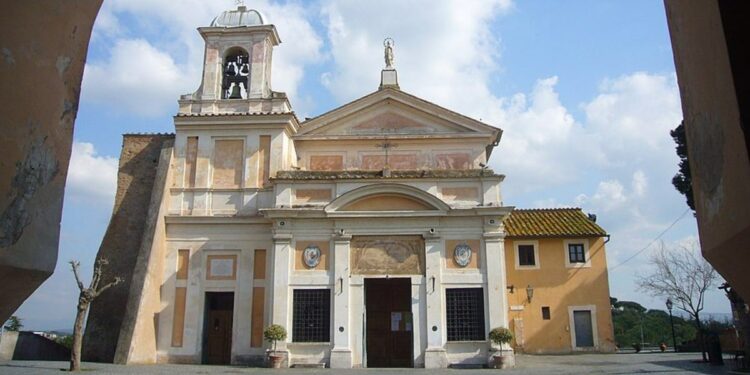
top-left (351, 236), bottom-right (424, 275)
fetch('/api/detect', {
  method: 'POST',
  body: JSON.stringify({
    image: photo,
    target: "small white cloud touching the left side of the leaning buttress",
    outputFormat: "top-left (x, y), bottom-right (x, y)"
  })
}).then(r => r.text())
top-left (65, 142), bottom-right (118, 205)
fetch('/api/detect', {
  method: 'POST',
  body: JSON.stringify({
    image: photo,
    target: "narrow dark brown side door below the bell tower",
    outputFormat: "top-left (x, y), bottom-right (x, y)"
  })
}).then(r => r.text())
top-left (203, 292), bottom-right (234, 365)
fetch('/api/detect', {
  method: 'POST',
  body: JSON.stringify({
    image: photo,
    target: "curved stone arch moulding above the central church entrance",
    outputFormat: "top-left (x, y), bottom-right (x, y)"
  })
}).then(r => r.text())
top-left (324, 183), bottom-right (451, 216)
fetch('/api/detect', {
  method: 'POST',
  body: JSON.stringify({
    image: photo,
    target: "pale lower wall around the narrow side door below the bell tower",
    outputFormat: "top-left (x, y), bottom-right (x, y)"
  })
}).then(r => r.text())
top-left (157, 222), bottom-right (273, 363)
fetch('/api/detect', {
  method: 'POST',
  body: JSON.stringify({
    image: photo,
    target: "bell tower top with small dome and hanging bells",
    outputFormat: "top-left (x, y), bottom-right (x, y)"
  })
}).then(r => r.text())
top-left (179, 5), bottom-right (285, 113)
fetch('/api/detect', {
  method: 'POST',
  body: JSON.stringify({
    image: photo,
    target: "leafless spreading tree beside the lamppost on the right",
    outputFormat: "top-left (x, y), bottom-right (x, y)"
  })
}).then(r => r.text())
top-left (636, 243), bottom-right (719, 361)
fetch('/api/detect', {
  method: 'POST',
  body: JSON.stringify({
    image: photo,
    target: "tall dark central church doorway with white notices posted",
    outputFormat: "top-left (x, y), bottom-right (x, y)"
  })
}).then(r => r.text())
top-left (365, 278), bottom-right (414, 367)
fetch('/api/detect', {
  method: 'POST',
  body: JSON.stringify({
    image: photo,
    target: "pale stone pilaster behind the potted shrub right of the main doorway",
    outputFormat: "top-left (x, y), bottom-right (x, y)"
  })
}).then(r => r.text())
top-left (484, 232), bottom-right (512, 366)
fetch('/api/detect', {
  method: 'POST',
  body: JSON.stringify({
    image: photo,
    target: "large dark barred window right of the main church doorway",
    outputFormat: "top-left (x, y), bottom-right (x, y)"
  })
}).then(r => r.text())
top-left (445, 288), bottom-right (485, 341)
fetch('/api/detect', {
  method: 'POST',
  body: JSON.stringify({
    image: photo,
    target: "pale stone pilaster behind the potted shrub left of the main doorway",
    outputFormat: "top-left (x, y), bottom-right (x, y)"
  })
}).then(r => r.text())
top-left (271, 233), bottom-right (294, 366)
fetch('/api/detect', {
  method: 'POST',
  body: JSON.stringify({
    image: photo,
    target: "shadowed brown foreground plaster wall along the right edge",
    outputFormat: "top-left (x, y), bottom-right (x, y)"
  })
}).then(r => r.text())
top-left (664, 0), bottom-right (750, 301)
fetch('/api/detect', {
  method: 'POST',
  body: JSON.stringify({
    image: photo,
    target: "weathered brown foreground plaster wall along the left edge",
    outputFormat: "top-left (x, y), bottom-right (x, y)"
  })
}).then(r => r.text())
top-left (0, 0), bottom-right (102, 321)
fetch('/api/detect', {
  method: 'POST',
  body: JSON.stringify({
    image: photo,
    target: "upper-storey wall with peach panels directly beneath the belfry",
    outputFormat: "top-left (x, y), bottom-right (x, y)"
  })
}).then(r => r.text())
top-left (169, 129), bottom-right (290, 216)
